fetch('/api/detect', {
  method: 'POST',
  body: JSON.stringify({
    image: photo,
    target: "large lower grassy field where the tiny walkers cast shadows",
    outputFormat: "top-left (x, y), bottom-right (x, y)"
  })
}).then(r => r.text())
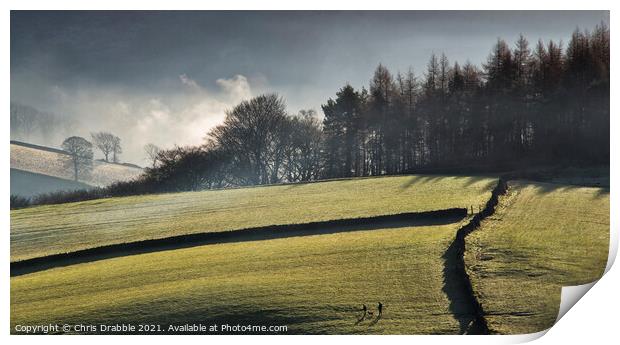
top-left (11, 220), bottom-right (470, 334)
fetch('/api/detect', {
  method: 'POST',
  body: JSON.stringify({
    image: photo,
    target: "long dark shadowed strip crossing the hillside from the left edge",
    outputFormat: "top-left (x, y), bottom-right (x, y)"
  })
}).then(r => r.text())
top-left (11, 208), bottom-right (467, 277)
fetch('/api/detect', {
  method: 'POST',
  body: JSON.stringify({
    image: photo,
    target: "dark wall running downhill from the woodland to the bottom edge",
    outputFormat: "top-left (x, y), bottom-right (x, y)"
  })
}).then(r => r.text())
top-left (444, 177), bottom-right (508, 334)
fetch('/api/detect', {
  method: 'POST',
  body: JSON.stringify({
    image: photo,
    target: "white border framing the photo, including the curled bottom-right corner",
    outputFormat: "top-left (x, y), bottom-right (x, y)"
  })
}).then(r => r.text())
top-left (0, 0), bottom-right (620, 345)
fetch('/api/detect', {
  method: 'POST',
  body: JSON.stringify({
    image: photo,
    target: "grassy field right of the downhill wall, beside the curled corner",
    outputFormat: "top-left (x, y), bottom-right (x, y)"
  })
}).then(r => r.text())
top-left (465, 181), bottom-right (609, 334)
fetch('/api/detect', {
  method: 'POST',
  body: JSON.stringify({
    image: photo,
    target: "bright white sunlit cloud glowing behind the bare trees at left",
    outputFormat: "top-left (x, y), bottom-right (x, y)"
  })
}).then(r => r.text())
top-left (38, 74), bottom-right (252, 164)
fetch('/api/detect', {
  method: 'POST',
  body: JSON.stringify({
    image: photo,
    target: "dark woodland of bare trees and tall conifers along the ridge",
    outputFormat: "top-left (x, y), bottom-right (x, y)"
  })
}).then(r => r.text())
top-left (15, 23), bottom-right (610, 207)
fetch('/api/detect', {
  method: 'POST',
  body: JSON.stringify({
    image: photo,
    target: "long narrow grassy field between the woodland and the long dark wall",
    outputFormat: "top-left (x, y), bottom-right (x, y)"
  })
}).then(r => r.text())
top-left (11, 175), bottom-right (497, 261)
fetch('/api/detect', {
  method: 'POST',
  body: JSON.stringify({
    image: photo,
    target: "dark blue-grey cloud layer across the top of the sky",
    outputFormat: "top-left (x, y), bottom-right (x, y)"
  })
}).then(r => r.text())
top-left (11, 11), bottom-right (608, 86)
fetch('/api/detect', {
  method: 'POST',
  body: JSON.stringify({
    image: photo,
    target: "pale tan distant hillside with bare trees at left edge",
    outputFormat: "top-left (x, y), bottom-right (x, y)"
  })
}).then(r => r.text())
top-left (11, 141), bottom-right (142, 189)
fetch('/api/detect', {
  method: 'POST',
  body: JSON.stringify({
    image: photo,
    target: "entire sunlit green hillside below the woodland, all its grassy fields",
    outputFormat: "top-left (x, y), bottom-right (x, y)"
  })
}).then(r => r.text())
top-left (11, 175), bottom-right (609, 334)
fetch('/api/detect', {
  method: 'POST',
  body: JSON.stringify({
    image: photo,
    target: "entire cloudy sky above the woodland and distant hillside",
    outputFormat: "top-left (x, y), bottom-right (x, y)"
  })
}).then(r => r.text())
top-left (10, 11), bottom-right (609, 164)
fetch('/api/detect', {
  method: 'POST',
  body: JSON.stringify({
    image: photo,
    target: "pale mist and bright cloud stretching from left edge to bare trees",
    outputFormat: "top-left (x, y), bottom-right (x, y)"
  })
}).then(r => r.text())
top-left (11, 74), bottom-right (260, 166)
